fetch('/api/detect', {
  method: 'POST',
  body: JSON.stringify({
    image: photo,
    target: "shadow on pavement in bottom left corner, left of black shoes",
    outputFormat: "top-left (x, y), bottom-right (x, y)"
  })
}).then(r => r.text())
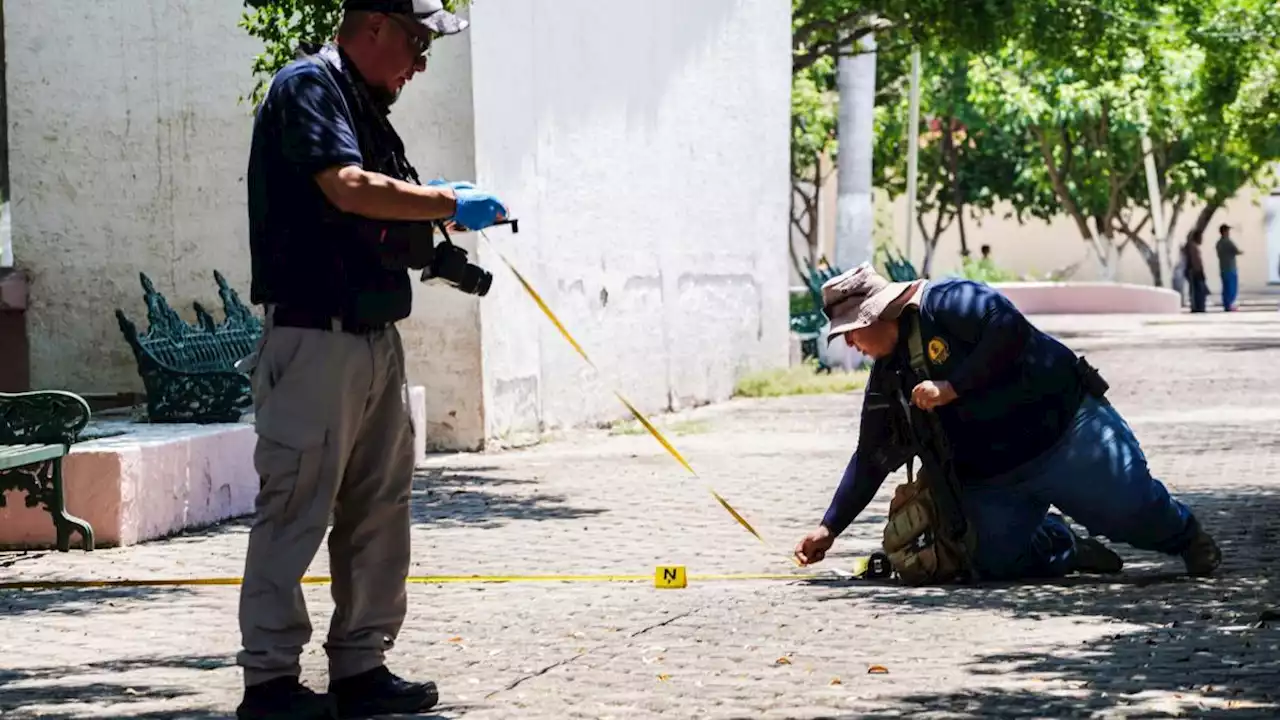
top-left (0, 655), bottom-right (233, 719)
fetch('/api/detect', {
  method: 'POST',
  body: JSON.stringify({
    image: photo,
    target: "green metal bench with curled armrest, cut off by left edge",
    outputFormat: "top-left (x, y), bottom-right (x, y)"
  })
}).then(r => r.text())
top-left (0, 391), bottom-right (93, 552)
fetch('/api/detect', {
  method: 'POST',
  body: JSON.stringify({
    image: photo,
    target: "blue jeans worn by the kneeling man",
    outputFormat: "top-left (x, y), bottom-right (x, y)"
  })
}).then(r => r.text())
top-left (961, 397), bottom-right (1193, 580)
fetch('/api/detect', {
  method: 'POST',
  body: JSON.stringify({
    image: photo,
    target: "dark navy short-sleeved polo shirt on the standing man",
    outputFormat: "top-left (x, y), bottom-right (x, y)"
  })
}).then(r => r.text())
top-left (247, 54), bottom-right (412, 322)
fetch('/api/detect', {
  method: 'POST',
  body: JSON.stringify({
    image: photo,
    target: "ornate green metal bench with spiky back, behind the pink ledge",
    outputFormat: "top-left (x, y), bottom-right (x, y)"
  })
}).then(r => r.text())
top-left (115, 272), bottom-right (262, 423)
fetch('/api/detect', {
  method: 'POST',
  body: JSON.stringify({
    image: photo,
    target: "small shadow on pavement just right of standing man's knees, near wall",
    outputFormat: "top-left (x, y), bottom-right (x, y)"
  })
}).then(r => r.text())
top-left (412, 468), bottom-right (608, 528)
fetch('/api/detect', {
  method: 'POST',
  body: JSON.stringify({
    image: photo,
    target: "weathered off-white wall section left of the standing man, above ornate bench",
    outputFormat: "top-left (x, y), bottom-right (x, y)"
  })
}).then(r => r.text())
top-left (5, 0), bottom-right (257, 392)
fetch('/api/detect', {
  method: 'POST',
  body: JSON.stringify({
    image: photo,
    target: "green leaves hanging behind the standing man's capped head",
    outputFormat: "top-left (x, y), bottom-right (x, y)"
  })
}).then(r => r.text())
top-left (241, 0), bottom-right (471, 106)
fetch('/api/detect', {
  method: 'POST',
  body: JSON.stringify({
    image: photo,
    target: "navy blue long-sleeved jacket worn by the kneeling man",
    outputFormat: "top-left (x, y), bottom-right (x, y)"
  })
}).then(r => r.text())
top-left (823, 279), bottom-right (1083, 534)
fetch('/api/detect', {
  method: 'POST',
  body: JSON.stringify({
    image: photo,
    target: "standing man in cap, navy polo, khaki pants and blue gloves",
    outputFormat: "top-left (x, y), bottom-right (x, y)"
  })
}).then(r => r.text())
top-left (237, 0), bottom-right (506, 719)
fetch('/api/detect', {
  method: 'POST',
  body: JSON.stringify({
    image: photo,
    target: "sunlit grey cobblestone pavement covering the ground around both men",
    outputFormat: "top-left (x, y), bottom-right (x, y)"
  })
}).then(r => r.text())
top-left (0, 313), bottom-right (1280, 719)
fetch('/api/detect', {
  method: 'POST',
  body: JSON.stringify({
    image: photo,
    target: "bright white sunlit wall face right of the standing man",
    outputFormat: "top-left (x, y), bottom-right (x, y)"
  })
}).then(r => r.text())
top-left (470, 0), bottom-right (791, 437)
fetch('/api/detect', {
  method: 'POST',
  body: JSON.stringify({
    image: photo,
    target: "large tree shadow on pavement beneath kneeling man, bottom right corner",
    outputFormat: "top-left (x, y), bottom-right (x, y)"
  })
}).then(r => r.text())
top-left (832, 488), bottom-right (1280, 717)
